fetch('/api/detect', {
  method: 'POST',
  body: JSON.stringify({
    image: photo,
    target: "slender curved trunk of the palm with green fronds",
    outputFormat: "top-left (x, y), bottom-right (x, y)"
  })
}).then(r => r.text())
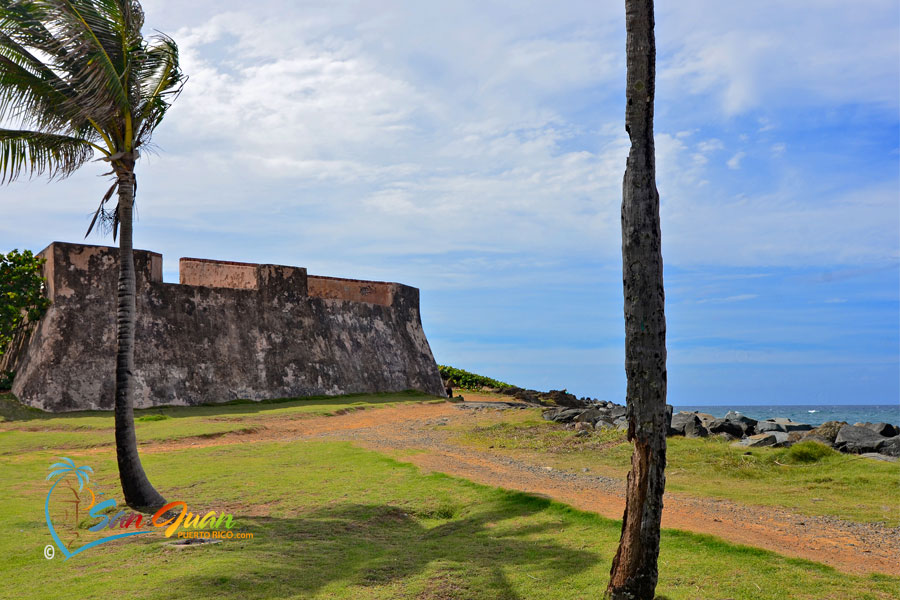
top-left (115, 162), bottom-right (166, 512)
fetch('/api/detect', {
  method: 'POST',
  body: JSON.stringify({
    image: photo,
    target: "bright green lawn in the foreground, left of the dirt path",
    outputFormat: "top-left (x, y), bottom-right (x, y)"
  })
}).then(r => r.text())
top-left (0, 396), bottom-right (900, 600)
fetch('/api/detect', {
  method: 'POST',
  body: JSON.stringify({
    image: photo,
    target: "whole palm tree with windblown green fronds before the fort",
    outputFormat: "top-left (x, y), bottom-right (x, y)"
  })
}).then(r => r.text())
top-left (0, 0), bottom-right (184, 511)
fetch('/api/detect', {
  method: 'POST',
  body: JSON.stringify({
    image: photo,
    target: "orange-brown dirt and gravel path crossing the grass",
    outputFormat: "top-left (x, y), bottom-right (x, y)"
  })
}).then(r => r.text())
top-left (130, 395), bottom-right (900, 575)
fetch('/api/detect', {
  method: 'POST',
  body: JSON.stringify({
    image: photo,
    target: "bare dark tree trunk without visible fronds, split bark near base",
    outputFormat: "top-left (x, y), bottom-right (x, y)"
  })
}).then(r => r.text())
top-left (606, 0), bottom-right (668, 600)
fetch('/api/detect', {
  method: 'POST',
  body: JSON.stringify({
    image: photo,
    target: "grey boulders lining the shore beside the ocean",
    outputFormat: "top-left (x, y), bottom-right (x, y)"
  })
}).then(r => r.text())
top-left (543, 402), bottom-right (900, 460)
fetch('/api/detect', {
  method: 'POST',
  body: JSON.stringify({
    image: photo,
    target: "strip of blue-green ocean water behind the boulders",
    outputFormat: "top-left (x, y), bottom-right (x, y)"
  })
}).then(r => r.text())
top-left (675, 404), bottom-right (900, 425)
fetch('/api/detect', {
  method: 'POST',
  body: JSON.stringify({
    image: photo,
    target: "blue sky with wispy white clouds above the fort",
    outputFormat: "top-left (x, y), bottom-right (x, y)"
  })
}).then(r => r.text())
top-left (0, 0), bottom-right (900, 405)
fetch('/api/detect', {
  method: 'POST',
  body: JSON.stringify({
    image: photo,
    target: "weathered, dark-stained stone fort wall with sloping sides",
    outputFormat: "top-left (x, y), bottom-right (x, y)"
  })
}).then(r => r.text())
top-left (7, 242), bottom-right (444, 411)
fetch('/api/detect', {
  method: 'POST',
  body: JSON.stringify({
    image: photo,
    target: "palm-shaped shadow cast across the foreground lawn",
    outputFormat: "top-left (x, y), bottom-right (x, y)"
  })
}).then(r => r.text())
top-left (171, 497), bottom-right (605, 599)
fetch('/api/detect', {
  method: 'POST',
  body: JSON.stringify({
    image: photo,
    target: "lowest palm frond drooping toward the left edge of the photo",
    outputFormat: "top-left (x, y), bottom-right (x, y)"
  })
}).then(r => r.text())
top-left (0, 129), bottom-right (94, 183)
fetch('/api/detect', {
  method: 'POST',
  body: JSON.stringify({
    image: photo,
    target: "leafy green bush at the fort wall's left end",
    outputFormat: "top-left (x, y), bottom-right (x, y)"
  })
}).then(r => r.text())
top-left (0, 250), bottom-right (50, 390)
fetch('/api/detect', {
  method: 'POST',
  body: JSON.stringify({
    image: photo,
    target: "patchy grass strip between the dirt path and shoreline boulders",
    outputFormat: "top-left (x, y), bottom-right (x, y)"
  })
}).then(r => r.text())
top-left (458, 418), bottom-right (900, 527)
